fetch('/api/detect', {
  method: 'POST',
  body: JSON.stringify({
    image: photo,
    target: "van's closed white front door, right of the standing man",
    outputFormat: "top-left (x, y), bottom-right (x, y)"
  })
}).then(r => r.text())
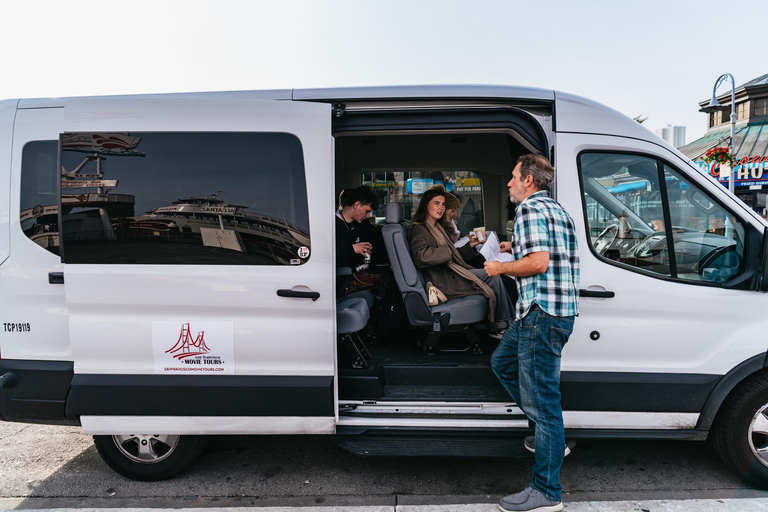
top-left (557, 133), bottom-right (768, 420)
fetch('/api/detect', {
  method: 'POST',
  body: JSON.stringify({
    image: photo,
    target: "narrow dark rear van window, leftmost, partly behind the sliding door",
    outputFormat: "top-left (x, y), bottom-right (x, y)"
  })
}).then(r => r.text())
top-left (19, 140), bottom-right (59, 254)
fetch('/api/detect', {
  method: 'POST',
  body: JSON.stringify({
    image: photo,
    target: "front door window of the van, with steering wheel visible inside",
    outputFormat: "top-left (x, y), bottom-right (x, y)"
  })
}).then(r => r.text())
top-left (579, 153), bottom-right (745, 283)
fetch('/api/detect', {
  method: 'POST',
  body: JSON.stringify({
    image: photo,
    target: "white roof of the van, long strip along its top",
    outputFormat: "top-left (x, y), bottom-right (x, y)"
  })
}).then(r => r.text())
top-left (10, 85), bottom-right (661, 142)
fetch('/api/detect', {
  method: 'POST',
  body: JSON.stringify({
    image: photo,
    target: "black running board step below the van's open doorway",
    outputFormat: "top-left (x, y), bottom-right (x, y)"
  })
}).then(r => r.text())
top-left (335, 435), bottom-right (533, 459)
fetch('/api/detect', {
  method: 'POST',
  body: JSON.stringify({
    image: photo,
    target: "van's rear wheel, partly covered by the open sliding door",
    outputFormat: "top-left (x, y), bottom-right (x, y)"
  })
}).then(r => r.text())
top-left (93, 434), bottom-right (207, 481)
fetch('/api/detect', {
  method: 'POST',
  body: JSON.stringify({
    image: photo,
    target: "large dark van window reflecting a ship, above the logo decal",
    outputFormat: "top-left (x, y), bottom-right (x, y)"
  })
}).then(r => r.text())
top-left (61, 132), bottom-right (310, 265)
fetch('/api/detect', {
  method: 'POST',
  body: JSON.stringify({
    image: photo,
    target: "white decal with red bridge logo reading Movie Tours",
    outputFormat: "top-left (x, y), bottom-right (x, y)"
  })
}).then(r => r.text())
top-left (152, 321), bottom-right (235, 375)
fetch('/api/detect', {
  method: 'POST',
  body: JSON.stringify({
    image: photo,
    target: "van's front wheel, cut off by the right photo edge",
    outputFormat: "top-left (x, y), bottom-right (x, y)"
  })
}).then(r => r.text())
top-left (712, 374), bottom-right (768, 488)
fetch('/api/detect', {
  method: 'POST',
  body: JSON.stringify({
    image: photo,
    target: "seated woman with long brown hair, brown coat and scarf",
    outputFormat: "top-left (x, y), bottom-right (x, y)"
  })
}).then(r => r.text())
top-left (408, 189), bottom-right (514, 331)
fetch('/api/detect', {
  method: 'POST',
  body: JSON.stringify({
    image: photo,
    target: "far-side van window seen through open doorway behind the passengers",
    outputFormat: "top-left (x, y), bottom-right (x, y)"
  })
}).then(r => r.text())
top-left (363, 171), bottom-right (485, 233)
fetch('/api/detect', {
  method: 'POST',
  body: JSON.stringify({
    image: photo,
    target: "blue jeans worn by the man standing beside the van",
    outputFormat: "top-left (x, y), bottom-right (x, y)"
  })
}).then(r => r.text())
top-left (491, 307), bottom-right (574, 501)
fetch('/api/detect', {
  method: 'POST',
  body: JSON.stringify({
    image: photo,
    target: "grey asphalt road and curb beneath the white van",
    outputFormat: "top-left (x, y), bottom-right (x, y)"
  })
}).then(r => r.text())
top-left (0, 423), bottom-right (768, 512)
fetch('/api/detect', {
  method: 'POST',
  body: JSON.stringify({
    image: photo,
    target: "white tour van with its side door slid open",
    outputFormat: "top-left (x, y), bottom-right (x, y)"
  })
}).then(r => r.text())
top-left (0, 86), bottom-right (768, 486)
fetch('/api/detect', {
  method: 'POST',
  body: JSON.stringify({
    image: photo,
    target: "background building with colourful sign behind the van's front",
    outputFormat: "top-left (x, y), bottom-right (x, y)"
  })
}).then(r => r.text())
top-left (680, 73), bottom-right (768, 216)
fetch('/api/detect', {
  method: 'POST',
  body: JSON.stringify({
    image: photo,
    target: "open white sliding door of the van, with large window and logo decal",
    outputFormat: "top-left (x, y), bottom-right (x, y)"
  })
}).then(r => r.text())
top-left (60, 98), bottom-right (336, 434)
